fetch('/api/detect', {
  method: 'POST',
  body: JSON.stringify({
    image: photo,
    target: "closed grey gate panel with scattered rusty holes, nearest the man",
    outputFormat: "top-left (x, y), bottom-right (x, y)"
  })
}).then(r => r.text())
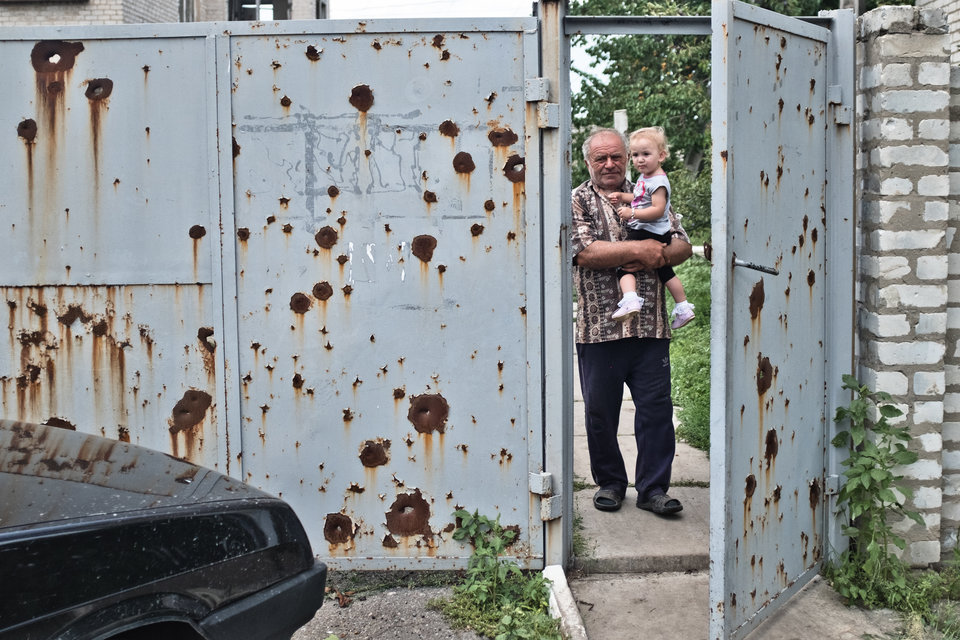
top-left (223, 19), bottom-right (543, 569)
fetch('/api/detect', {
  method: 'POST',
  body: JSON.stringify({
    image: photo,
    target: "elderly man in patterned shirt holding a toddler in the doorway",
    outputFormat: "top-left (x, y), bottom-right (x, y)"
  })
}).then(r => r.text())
top-left (571, 129), bottom-right (692, 515)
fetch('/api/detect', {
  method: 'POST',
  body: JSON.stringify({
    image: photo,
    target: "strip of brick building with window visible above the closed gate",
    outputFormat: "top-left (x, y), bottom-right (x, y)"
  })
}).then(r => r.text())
top-left (0, 0), bottom-right (329, 27)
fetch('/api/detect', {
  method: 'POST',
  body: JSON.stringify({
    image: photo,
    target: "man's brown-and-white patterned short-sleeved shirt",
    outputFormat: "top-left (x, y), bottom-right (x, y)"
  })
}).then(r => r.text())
top-left (570, 175), bottom-right (690, 343)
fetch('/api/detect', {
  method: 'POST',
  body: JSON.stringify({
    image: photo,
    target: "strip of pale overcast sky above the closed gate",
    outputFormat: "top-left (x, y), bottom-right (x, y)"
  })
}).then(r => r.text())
top-left (328, 0), bottom-right (533, 19)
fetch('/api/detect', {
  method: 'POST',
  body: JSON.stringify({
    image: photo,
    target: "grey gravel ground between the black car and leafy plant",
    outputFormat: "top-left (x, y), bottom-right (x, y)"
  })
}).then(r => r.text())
top-left (292, 571), bottom-right (483, 640)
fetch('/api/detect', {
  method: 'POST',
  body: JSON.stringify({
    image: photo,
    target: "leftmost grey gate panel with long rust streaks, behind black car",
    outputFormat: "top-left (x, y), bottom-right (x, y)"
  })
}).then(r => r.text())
top-left (0, 26), bottom-right (228, 468)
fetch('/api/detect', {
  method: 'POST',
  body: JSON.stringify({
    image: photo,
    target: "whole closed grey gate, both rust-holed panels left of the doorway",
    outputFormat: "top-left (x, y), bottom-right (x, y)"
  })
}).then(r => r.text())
top-left (0, 19), bottom-right (563, 569)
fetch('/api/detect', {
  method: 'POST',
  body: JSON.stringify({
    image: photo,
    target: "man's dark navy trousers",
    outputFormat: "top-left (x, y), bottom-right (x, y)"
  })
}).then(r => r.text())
top-left (577, 338), bottom-right (676, 501)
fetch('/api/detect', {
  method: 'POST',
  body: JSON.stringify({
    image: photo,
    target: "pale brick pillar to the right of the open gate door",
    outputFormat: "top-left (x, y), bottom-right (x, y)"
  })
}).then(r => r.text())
top-left (857, 6), bottom-right (948, 565)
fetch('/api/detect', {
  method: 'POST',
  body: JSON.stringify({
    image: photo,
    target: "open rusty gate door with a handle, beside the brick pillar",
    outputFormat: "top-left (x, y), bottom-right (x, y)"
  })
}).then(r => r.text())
top-left (710, 2), bottom-right (853, 639)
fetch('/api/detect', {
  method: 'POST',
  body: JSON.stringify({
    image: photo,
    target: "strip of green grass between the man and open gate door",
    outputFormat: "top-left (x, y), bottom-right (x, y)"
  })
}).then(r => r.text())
top-left (668, 255), bottom-right (710, 451)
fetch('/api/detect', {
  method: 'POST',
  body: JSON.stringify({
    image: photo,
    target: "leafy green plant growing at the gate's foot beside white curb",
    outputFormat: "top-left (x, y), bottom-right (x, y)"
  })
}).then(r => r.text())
top-left (432, 509), bottom-right (561, 640)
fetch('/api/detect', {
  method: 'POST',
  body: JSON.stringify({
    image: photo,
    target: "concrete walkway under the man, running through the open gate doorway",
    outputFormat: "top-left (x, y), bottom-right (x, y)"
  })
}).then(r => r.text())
top-left (564, 362), bottom-right (900, 640)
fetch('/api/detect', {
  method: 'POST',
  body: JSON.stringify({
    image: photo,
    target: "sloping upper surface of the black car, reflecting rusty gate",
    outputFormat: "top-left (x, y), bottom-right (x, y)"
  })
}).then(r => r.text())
top-left (0, 420), bottom-right (272, 531)
